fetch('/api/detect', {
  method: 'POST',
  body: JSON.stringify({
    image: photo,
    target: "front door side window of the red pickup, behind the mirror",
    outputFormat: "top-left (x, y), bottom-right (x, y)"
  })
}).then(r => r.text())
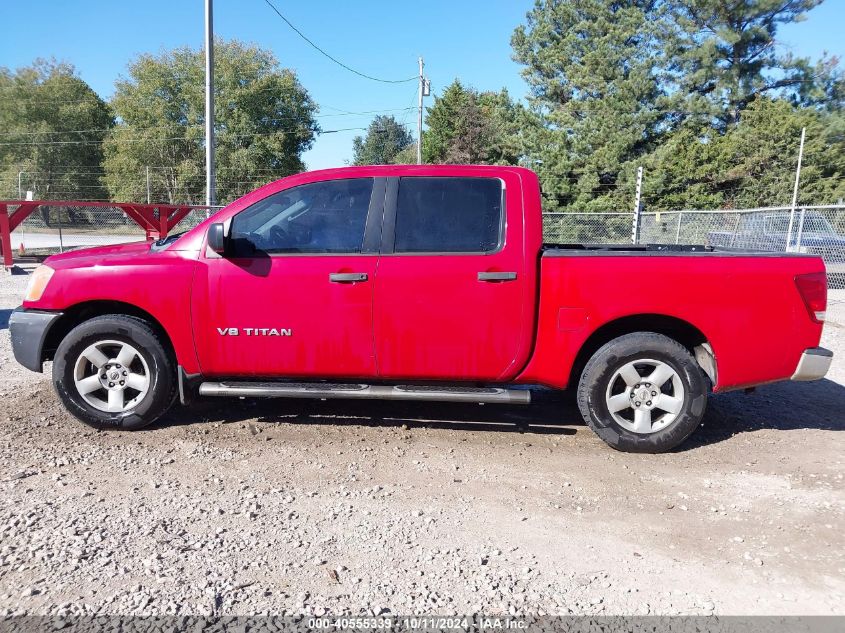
top-left (231, 178), bottom-right (373, 256)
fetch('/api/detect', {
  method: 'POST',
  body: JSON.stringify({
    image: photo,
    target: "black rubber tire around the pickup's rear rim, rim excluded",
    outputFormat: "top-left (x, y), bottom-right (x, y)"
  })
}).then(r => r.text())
top-left (577, 332), bottom-right (709, 453)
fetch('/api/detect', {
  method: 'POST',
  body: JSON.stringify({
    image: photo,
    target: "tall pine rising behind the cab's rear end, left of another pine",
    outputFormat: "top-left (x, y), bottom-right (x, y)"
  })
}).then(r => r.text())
top-left (511, 0), bottom-right (669, 210)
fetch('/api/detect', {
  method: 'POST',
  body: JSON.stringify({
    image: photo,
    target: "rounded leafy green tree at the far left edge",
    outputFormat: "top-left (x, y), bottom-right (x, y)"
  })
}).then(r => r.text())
top-left (0, 59), bottom-right (114, 200)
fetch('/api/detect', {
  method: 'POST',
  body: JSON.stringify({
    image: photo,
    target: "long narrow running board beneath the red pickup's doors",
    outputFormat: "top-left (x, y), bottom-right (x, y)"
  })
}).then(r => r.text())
top-left (199, 381), bottom-right (531, 404)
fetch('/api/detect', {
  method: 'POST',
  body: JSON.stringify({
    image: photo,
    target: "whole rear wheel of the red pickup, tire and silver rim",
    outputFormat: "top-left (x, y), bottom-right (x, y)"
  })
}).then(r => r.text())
top-left (577, 332), bottom-right (708, 453)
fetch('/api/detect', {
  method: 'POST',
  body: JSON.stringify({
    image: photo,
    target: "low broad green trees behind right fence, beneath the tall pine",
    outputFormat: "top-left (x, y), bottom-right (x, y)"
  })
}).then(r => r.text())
top-left (644, 97), bottom-right (845, 210)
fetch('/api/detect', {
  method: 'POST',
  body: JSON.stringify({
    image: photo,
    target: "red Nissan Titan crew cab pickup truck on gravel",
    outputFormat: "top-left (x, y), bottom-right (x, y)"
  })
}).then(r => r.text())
top-left (9, 166), bottom-right (832, 452)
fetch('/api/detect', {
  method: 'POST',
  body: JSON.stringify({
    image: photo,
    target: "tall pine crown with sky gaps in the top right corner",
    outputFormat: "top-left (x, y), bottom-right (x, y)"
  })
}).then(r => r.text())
top-left (667, 0), bottom-right (845, 131)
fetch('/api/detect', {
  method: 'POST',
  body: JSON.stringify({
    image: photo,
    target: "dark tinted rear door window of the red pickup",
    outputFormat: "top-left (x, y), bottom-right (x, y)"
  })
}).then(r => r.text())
top-left (393, 177), bottom-right (503, 253)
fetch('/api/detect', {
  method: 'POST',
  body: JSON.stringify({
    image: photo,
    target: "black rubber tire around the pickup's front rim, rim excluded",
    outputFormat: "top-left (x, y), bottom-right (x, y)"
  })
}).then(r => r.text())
top-left (53, 314), bottom-right (177, 431)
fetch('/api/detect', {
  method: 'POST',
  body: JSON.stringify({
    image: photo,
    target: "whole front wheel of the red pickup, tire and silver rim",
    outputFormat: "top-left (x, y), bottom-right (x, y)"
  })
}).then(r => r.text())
top-left (53, 315), bottom-right (176, 431)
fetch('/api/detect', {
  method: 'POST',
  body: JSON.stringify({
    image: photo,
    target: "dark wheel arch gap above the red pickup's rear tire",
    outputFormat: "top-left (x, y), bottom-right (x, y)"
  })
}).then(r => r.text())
top-left (569, 314), bottom-right (717, 385)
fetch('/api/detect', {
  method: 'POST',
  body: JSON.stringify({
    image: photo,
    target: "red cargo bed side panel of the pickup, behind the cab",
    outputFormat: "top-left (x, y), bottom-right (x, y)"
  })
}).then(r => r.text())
top-left (529, 244), bottom-right (824, 391)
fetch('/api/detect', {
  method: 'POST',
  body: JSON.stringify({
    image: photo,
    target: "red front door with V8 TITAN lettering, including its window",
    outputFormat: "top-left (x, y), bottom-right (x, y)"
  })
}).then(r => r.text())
top-left (192, 178), bottom-right (384, 378)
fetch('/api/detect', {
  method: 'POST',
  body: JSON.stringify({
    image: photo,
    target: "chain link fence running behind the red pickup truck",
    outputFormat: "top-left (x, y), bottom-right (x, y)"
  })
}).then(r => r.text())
top-left (12, 204), bottom-right (845, 289)
